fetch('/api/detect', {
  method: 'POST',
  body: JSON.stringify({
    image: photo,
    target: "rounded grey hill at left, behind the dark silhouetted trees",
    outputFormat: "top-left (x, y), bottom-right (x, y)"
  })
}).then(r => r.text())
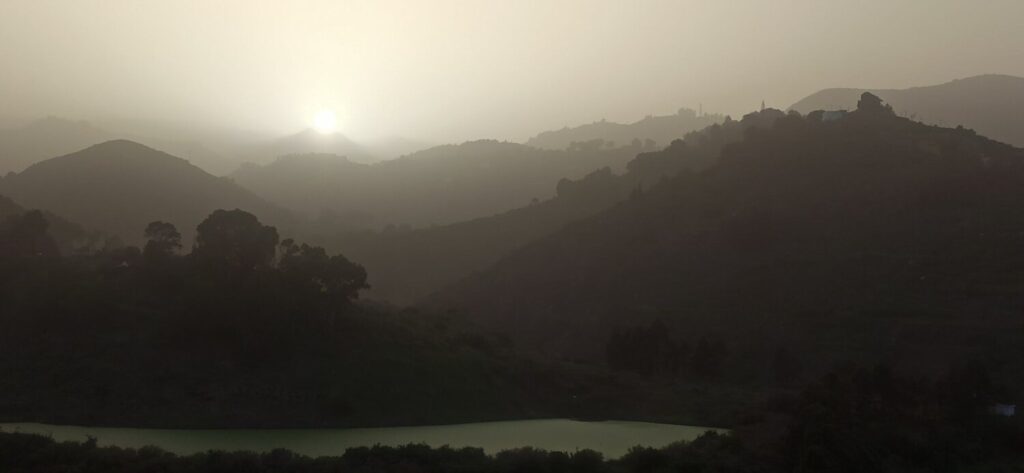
top-left (0, 140), bottom-right (293, 243)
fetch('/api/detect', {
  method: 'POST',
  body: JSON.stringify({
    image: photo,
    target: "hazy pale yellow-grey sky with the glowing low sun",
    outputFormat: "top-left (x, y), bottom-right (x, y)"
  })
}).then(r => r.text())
top-left (0, 0), bottom-right (1024, 141)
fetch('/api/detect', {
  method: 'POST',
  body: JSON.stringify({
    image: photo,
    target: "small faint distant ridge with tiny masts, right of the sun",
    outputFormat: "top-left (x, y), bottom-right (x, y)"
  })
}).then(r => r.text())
top-left (526, 109), bottom-right (725, 149)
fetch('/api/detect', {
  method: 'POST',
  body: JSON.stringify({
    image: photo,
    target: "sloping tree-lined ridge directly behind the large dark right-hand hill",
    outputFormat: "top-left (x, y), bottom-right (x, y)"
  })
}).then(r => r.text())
top-left (317, 110), bottom-right (783, 304)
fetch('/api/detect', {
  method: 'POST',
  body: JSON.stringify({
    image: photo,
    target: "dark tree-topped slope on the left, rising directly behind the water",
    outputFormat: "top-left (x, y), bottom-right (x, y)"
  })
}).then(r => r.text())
top-left (0, 210), bottom-right (757, 427)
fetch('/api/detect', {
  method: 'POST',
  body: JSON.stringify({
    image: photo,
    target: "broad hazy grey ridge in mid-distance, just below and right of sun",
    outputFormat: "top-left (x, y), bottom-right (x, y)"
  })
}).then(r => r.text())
top-left (232, 140), bottom-right (643, 232)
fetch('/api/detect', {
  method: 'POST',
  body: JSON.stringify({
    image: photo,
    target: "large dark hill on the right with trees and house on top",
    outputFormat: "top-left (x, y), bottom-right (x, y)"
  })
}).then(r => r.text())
top-left (434, 95), bottom-right (1024, 391)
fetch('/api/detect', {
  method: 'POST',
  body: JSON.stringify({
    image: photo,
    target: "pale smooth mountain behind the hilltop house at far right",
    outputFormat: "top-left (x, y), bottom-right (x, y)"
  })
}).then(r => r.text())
top-left (790, 75), bottom-right (1024, 146)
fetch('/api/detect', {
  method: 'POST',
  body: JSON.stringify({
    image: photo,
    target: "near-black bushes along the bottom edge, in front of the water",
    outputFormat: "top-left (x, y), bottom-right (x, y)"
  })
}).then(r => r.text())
top-left (0, 363), bottom-right (1024, 473)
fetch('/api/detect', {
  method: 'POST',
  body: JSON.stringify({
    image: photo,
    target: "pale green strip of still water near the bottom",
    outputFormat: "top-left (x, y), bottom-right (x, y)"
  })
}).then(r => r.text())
top-left (0, 419), bottom-right (715, 458)
